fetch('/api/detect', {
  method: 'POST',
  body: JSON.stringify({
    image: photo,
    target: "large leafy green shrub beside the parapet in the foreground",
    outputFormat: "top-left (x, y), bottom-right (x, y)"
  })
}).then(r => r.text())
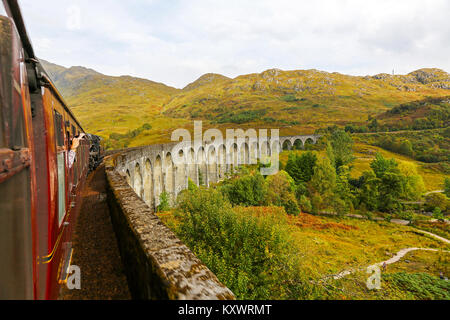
top-left (177, 189), bottom-right (314, 299)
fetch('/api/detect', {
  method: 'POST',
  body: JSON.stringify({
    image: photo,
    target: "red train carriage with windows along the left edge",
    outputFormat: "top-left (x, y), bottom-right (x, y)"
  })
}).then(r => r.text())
top-left (0, 0), bottom-right (90, 299)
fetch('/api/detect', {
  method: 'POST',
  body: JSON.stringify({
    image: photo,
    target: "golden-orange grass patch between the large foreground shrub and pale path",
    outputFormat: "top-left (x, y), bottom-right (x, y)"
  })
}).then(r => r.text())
top-left (284, 214), bottom-right (448, 277)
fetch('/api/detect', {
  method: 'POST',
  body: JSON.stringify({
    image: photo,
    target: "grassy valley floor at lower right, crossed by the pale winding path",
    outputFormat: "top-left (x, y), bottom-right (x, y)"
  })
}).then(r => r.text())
top-left (159, 207), bottom-right (450, 300)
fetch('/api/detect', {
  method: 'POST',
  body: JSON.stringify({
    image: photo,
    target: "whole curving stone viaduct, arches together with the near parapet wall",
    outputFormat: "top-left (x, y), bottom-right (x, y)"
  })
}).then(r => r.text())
top-left (105, 135), bottom-right (319, 300)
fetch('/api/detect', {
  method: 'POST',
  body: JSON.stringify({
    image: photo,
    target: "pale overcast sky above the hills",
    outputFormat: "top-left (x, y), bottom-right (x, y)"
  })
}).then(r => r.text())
top-left (19, 0), bottom-right (450, 88)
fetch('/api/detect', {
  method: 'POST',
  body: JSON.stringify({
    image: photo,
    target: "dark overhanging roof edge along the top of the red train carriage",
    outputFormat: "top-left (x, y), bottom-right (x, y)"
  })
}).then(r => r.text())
top-left (3, 0), bottom-right (85, 132)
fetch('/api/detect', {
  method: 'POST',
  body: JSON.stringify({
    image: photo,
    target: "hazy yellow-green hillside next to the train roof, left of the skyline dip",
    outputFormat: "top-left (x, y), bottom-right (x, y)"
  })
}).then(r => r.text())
top-left (41, 60), bottom-right (181, 138)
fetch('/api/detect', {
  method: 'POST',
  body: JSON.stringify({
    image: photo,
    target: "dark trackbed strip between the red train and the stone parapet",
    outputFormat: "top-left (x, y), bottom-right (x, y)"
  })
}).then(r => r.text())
top-left (59, 165), bottom-right (131, 300)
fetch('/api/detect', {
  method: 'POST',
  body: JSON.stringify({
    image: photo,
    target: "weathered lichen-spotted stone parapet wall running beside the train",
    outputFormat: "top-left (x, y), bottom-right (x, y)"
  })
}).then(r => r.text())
top-left (106, 155), bottom-right (235, 300)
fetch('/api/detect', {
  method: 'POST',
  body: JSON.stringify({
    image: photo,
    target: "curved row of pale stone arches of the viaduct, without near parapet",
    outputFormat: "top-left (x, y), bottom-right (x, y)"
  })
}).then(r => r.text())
top-left (116, 135), bottom-right (319, 210)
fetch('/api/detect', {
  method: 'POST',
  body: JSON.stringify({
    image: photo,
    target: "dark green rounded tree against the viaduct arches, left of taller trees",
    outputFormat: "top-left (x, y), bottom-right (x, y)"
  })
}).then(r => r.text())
top-left (285, 151), bottom-right (317, 184)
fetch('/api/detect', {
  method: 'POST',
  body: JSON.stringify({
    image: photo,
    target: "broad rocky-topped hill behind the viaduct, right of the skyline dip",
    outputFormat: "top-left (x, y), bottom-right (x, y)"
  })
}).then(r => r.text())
top-left (164, 69), bottom-right (450, 131)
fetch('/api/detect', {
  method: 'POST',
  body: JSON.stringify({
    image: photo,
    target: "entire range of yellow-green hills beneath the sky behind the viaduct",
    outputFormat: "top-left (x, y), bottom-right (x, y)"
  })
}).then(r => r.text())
top-left (36, 60), bottom-right (450, 148)
